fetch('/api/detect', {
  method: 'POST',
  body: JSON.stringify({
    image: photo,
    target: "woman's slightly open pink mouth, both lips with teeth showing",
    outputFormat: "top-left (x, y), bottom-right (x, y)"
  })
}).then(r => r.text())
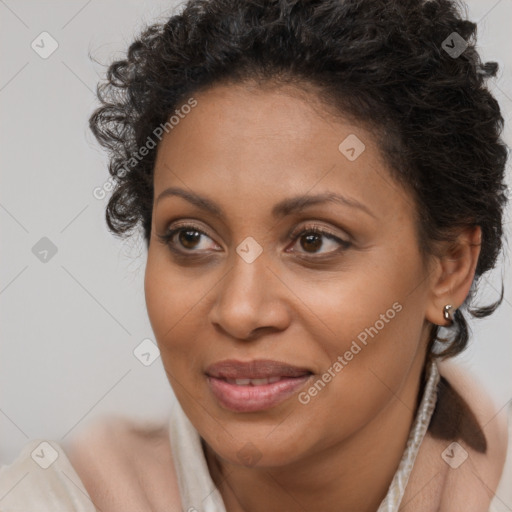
top-left (205, 359), bottom-right (313, 412)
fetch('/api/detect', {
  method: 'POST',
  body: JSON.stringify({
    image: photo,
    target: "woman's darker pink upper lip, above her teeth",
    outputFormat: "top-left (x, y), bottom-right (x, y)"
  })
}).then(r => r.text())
top-left (205, 359), bottom-right (311, 379)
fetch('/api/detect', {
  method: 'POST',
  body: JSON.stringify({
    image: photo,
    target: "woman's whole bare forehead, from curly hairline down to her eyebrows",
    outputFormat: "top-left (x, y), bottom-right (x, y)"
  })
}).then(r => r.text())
top-left (154, 85), bottom-right (410, 222)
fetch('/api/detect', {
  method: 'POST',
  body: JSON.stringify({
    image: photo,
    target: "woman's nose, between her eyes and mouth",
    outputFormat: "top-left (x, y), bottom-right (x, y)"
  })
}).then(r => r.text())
top-left (209, 248), bottom-right (291, 341)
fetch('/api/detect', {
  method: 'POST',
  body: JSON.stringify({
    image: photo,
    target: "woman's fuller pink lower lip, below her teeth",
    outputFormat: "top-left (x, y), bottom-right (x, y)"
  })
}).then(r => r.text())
top-left (207, 375), bottom-right (311, 412)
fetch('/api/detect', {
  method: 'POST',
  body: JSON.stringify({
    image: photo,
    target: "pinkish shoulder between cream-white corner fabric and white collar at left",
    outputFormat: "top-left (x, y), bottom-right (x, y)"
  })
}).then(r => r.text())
top-left (66, 416), bottom-right (181, 512)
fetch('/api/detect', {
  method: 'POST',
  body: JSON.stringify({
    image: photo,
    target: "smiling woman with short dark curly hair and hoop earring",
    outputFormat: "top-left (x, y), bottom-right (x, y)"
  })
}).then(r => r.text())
top-left (0, 0), bottom-right (512, 512)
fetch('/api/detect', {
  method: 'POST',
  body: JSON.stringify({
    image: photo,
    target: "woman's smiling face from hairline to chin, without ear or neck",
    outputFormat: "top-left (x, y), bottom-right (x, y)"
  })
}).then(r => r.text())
top-left (145, 85), bottom-right (436, 466)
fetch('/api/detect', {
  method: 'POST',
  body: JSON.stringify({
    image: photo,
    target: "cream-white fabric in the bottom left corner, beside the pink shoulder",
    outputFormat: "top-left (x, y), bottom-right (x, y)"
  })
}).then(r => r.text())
top-left (0, 439), bottom-right (96, 512)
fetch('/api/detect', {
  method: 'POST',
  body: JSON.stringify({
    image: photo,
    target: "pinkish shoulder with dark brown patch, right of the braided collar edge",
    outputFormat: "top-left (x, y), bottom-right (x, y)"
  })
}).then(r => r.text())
top-left (404, 361), bottom-right (509, 512)
